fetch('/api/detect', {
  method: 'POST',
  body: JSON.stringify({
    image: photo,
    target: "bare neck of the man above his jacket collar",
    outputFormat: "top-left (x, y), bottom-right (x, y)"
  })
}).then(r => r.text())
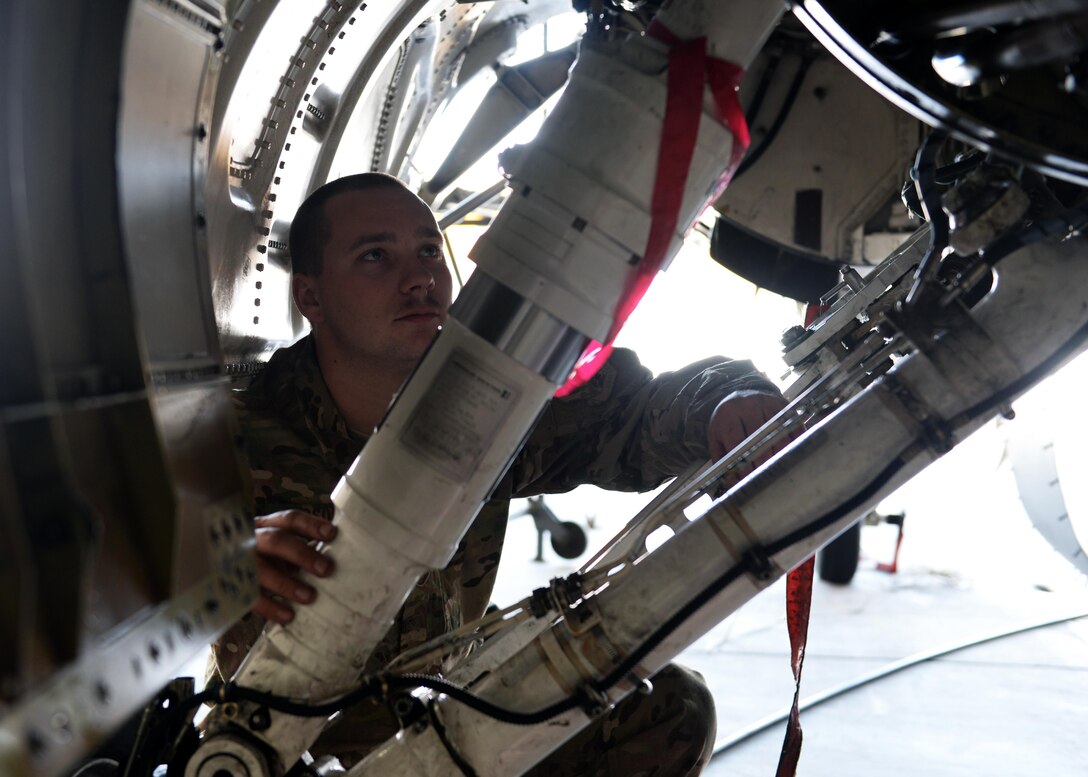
top-left (314, 340), bottom-right (411, 434)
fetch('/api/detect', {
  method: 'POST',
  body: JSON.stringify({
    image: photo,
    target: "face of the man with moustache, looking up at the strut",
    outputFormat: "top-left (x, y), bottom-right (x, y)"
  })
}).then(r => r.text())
top-left (296, 189), bottom-right (453, 369)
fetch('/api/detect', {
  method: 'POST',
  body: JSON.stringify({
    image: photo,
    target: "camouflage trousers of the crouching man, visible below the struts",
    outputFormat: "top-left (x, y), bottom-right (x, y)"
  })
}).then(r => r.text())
top-left (310, 664), bottom-right (717, 777)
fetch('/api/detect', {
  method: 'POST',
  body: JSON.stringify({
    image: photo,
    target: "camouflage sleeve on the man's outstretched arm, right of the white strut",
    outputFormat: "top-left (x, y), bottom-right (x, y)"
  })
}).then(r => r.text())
top-left (507, 348), bottom-right (778, 496)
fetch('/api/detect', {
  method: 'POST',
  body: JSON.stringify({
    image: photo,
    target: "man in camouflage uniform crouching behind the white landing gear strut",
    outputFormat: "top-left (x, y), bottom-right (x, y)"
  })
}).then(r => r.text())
top-left (207, 174), bottom-right (782, 775)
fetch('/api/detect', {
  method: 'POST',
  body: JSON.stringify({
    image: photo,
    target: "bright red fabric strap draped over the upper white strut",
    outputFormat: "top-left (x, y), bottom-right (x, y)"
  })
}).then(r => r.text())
top-left (556, 22), bottom-right (749, 396)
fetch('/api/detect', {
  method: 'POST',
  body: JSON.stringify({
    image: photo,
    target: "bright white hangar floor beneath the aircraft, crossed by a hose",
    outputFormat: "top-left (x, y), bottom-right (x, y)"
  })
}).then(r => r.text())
top-left (496, 417), bottom-right (1088, 777)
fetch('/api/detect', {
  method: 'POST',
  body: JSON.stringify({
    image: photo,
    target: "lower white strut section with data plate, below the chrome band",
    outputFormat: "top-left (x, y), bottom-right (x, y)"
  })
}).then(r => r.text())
top-left (186, 319), bottom-right (555, 777)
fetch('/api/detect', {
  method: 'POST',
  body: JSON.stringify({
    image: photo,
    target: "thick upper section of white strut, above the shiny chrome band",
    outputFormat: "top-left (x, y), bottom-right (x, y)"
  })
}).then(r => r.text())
top-left (471, 21), bottom-right (761, 342)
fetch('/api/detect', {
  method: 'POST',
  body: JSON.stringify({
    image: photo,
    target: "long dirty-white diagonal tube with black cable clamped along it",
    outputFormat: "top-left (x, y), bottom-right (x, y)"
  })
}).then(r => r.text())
top-left (350, 232), bottom-right (1088, 777)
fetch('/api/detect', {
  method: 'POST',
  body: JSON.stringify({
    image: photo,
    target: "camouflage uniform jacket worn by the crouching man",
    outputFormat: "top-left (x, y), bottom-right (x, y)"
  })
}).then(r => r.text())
top-left (213, 337), bottom-right (777, 677)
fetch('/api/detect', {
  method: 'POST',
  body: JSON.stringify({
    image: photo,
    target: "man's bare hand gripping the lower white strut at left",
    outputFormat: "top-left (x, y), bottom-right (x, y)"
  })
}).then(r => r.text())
top-left (252, 510), bottom-right (336, 624)
